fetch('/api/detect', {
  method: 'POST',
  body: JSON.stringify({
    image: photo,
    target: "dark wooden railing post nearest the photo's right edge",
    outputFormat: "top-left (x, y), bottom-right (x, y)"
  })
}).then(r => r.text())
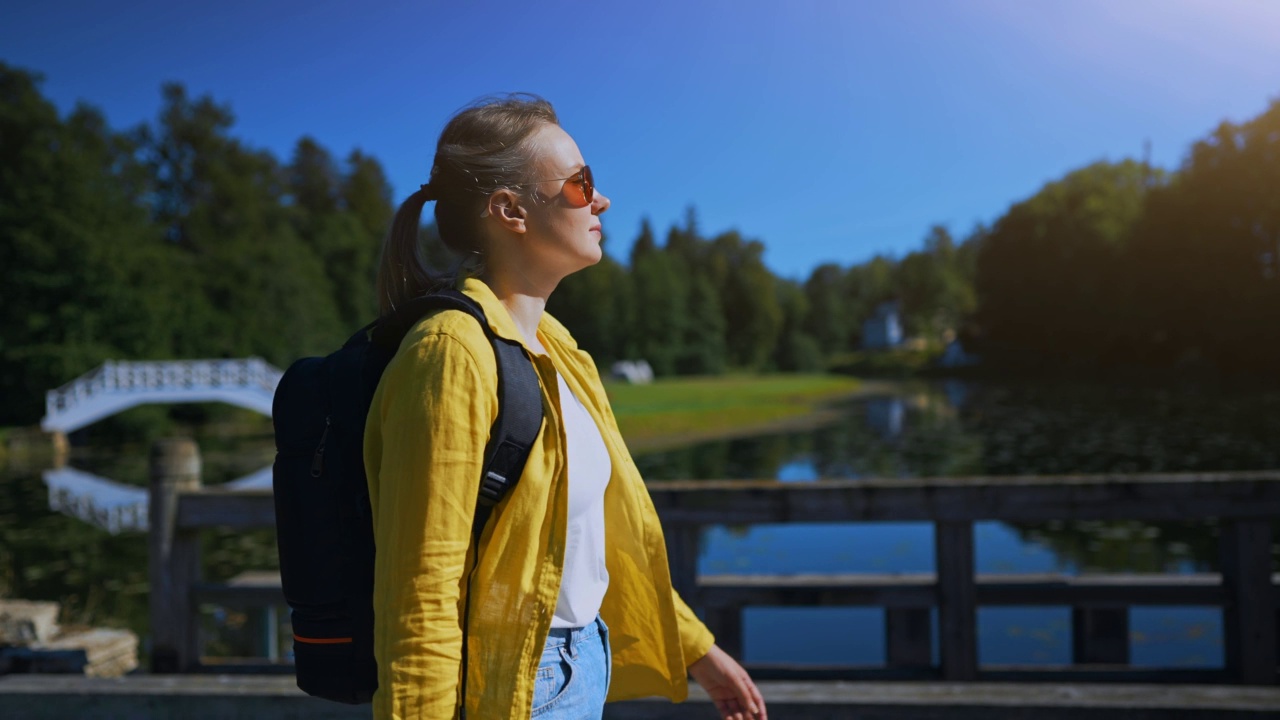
top-left (1220, 519), bottom-right (1276, 685)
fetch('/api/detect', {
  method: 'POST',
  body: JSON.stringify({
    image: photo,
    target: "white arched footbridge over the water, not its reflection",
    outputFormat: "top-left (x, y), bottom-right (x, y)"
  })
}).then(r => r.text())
top-left (40, 357), bottom-right (282, 433)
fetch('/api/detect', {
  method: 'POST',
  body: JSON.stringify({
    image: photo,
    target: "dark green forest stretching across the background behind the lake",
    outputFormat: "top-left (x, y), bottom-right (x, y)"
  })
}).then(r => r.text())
top-left (0, 64), bottom-right (1280, 424)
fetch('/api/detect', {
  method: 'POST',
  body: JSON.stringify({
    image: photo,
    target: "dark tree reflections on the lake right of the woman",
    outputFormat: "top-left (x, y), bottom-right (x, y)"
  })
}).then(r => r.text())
top-left (636, 380), bottom-right (1280, 571)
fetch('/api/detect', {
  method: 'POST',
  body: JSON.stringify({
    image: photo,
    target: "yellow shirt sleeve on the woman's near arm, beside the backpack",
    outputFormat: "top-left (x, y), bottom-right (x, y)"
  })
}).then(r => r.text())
top-left (365, 334), bottom-right (497, 720)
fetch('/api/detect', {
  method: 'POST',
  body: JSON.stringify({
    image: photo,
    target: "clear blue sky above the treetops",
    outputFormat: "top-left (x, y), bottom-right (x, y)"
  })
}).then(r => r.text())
top-left (0, 0), bottom-right (1280, 278)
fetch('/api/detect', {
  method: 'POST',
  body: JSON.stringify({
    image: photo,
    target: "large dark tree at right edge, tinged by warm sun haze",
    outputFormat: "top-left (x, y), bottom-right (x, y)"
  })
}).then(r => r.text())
top-left (1124, 101), bottom-right (1280, 374)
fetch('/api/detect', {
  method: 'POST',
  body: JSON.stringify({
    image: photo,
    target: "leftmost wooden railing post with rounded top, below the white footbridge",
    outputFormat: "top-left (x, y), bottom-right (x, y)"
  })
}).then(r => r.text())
top-left (147, 439), bottom-right (200, 673)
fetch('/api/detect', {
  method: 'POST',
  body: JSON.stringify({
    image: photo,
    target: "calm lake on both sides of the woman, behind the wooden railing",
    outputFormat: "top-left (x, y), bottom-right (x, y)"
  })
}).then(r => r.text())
top-left (0, 380), bottom-right (1280, 667)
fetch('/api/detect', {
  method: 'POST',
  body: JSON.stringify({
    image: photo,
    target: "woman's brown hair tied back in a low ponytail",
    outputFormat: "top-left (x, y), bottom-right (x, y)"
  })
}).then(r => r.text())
top-left (378, 94), bottom-right (559, 315)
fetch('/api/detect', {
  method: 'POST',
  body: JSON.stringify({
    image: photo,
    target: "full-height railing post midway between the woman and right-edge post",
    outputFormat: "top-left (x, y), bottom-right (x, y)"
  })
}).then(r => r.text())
top-left (933, 520), bottom-right (978, 680)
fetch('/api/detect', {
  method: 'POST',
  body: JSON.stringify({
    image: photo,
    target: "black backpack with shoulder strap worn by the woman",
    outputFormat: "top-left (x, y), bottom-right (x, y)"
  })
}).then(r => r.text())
top-left (271, 290), bottom-right (543, 705)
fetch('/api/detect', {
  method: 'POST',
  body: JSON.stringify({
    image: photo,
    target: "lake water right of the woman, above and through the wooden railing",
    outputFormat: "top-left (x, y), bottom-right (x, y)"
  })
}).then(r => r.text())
top-left (636, 380), bottom-right (1280, 666)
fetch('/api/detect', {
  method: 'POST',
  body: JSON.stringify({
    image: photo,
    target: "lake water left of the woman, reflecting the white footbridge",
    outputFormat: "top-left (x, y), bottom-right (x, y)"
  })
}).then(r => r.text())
top-left (0, 418), bottom-right (279, 661)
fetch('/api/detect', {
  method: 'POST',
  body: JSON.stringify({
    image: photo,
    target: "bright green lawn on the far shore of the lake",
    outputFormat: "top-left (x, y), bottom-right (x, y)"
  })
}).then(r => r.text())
top-left (605, 374), bottom-right (860, 451)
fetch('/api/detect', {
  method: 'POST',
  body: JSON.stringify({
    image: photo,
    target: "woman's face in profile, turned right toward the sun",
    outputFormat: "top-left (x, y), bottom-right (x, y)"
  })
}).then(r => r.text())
top-left (522, 126), bottom-right (609, 277)
